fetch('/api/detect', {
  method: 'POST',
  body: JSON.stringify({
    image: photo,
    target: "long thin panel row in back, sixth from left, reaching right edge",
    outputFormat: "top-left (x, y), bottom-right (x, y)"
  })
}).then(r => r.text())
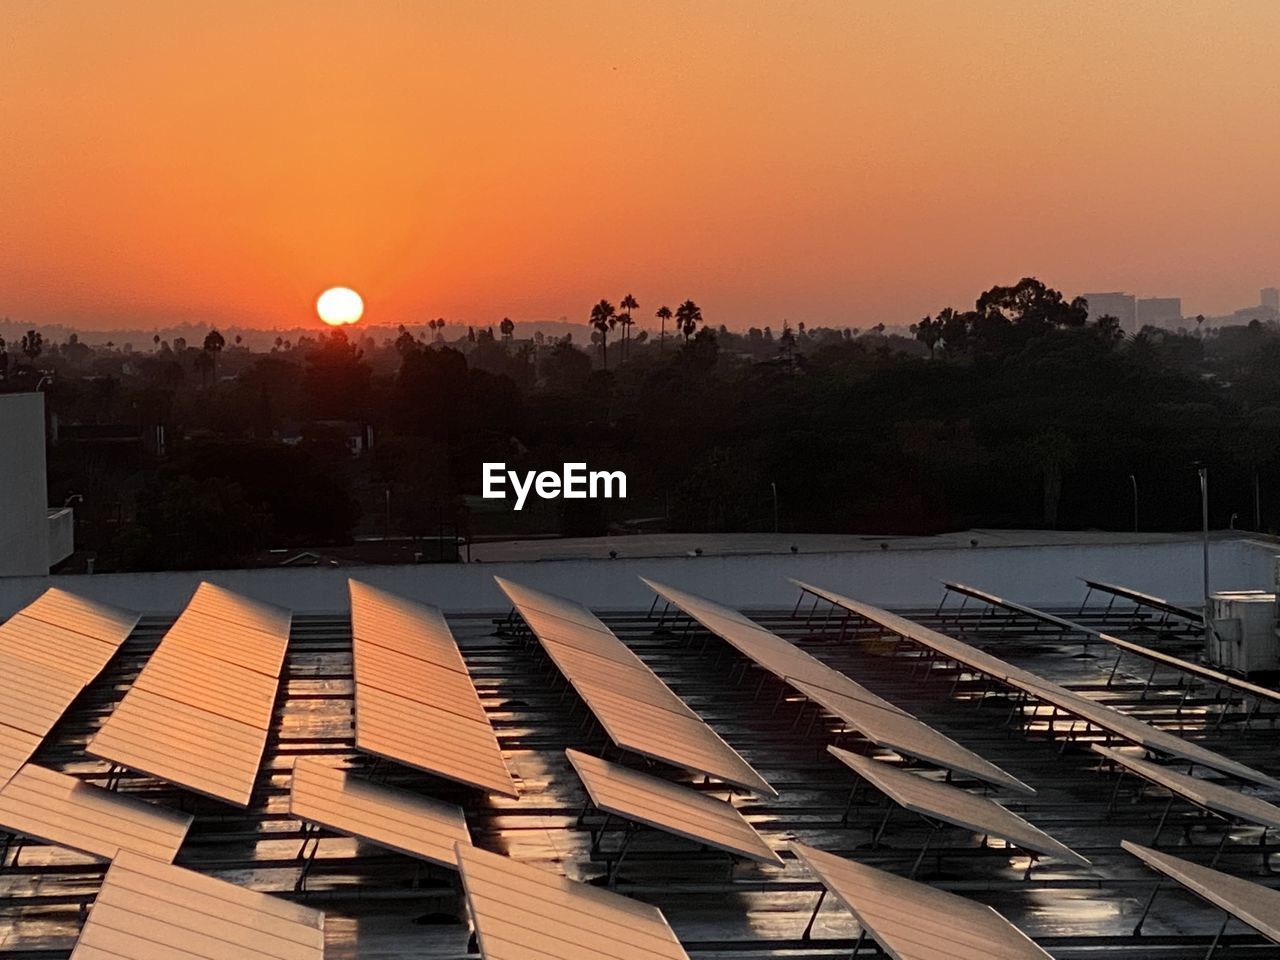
top-left (791, 580), bottom-right (1280, 788)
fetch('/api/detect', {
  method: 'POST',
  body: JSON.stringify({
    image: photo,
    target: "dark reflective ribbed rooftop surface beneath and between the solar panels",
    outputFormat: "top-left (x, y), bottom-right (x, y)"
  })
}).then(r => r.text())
top-left (0, 591), bottom-right (1280, 960)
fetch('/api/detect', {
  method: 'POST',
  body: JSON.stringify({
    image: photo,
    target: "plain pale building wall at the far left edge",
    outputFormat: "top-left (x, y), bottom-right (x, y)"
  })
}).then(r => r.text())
top-left (0, 393), bottom-right (49, 576)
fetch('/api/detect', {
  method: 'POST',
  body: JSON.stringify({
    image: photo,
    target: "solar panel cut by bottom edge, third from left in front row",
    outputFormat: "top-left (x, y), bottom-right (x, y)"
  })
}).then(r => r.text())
top-left (791, 842), bottom-right (1050, 960)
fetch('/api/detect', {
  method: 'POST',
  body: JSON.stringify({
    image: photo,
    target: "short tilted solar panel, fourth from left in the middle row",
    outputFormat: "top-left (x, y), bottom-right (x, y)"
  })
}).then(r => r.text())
top-left (827, 746), bottom-right (1089, 867)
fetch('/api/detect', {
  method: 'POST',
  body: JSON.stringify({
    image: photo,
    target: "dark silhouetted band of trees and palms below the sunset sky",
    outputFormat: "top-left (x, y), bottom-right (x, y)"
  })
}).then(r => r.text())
top-left (10, 278), bottom-right (1280, 568)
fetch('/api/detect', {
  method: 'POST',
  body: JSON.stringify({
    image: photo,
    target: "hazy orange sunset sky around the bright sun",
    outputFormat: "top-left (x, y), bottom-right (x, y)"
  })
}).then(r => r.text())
top-left (0, 0), bottom-right (1280, 328)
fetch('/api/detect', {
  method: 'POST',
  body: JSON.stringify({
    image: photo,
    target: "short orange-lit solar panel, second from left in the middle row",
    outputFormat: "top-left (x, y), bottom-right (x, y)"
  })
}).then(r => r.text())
top-left (289, 758), bottom-right (471, 867)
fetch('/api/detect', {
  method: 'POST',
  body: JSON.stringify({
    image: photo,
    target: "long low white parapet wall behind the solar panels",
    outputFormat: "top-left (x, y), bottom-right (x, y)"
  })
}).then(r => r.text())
top-left (0, 536), bottom-right (1280, 617)
